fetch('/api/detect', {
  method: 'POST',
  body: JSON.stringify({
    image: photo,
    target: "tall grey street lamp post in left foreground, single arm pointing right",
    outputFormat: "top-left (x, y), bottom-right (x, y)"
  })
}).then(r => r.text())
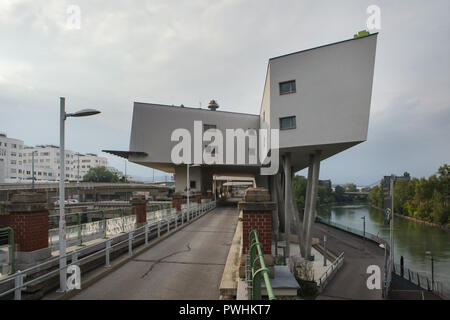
top-left (59, 97), bottom-right (100, 292)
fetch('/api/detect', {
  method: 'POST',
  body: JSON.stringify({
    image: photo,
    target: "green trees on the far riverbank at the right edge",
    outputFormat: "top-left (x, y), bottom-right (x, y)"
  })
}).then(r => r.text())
top-left (369, 164), bottom-right (450, 224)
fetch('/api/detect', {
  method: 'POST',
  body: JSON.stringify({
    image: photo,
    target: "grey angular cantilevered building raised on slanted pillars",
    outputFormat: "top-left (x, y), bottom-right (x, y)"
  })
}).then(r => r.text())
top-left (107, 34), bottom-right (377, 258)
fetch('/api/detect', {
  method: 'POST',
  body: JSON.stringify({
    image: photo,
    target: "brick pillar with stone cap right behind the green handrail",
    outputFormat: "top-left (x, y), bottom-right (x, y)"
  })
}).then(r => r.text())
top-left (238, 188), bottom-right (276, 276)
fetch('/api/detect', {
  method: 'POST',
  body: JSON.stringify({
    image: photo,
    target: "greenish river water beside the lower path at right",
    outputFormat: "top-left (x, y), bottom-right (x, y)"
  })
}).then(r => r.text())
top-left (317, 204), bottom-right (450, 287)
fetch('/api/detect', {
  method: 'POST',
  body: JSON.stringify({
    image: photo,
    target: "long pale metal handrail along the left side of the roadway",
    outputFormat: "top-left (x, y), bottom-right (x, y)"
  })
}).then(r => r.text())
top-left (0, 201), bottom-right (216, 300)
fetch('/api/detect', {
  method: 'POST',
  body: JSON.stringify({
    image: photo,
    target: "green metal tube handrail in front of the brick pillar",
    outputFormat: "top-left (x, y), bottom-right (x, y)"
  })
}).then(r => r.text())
top-left (249, 230), bottom-right (276, 300)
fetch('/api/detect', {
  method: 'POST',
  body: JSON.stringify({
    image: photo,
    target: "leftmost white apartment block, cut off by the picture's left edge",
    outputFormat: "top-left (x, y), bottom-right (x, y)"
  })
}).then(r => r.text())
top-left (0, 133), bottom-right (24, 183)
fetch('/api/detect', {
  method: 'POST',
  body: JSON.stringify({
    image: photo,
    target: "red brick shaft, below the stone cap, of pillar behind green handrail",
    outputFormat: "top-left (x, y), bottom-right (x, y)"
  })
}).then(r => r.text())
top-left (242, 210), bottom-right (272, 254)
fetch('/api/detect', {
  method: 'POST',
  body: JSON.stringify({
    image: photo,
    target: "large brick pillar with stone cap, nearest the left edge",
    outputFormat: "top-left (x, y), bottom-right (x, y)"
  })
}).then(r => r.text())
top-left (0, 192), bottom-right (51, 270)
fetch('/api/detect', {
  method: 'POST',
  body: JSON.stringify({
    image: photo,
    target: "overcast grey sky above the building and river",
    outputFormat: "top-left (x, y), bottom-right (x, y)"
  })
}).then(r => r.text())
top-left (0, 0), bottom-right (450, 185)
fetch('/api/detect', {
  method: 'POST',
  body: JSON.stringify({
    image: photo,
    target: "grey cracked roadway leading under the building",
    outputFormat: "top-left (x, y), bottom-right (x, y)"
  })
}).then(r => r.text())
top-left (73, 207), bottom-right (238, 300)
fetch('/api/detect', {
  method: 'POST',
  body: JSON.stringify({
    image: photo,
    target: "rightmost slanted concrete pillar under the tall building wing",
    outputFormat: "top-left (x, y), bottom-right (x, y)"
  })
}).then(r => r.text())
top-left (302, 151), bottom-right (321, 260)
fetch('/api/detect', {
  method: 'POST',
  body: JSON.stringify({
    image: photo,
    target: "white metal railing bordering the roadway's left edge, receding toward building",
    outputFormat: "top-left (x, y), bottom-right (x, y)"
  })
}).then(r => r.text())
top-left (0, 201), bottom-right (216, 300)
